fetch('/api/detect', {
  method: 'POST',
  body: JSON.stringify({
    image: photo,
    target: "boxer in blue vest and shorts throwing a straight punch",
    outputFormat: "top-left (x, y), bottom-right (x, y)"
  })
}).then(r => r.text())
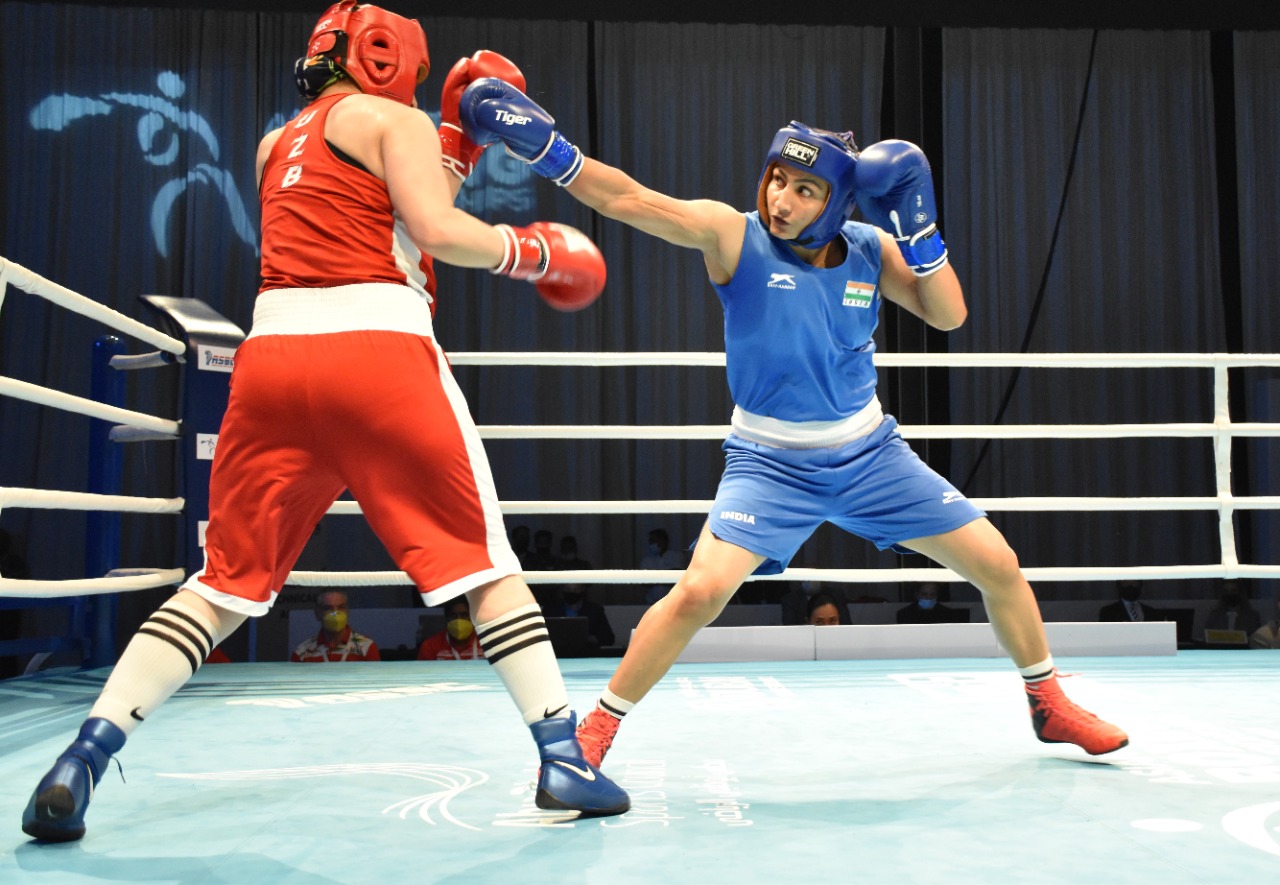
top-left (460, 78), bottom-right (1129, 763)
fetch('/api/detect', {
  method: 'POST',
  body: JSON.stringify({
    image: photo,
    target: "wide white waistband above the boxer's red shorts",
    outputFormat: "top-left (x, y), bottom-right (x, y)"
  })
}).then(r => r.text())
top-left (248, 283), bottom-right (434, 338)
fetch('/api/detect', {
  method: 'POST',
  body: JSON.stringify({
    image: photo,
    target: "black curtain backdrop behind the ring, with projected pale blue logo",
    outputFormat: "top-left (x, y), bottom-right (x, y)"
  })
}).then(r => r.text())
top-left (0, 3), bottom-right (1280, 622)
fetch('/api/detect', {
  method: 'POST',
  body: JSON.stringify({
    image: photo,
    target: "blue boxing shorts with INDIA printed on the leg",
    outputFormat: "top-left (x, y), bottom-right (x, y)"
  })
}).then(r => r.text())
top-left (708, 415), bottom-right (986, 575)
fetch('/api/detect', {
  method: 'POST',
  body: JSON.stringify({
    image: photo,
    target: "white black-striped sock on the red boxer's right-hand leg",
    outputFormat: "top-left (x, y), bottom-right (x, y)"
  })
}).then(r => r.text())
top-left (476, 603), bottom-right (572, 725)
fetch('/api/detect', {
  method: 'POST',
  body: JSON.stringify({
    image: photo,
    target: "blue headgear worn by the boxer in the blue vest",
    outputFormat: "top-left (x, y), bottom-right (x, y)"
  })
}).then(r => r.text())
top-left (755, 120), bottom-right (858, 248)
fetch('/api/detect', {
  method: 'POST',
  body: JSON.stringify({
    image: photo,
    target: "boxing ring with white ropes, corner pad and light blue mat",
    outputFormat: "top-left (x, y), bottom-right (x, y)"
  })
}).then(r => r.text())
top-left (0, 260), bottom-right (1280, 884)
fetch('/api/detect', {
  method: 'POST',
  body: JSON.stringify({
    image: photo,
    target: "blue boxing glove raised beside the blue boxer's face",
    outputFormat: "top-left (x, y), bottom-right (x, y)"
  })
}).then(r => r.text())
top-left (855, 138), bottom-right (947, 277)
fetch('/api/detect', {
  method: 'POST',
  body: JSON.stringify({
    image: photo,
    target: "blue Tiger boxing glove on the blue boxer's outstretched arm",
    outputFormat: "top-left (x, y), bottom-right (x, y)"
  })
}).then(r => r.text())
top-left (458, 77), bottom-right (582, 187)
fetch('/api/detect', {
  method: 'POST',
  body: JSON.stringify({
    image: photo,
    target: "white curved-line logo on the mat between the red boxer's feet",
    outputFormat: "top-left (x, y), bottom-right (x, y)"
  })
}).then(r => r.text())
top-left (159, 762), bottom-right (489, 830)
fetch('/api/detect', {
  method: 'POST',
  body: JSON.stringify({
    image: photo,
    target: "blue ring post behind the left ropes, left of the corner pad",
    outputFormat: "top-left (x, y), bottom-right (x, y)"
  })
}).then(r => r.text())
top-left (84, 334), bottom-right (125, 667)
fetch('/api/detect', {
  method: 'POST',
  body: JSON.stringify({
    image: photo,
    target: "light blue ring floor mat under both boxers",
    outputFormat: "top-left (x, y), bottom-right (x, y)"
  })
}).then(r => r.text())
top-left (0, 651), bottom-right (1280, 885)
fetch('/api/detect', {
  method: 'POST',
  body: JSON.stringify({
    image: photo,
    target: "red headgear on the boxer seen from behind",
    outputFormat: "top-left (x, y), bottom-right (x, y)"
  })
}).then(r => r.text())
top-left (293, 0), bottom-right (431, 105)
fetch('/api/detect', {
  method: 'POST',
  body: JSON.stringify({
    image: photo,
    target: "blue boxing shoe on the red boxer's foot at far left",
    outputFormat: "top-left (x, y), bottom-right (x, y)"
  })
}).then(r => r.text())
top-left (22, 719), bottom-right (124, 841)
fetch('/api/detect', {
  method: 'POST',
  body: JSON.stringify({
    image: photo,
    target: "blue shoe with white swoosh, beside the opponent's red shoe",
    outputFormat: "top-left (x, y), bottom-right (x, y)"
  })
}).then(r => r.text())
top-left (529, 715), bottom-right (631, 817)
